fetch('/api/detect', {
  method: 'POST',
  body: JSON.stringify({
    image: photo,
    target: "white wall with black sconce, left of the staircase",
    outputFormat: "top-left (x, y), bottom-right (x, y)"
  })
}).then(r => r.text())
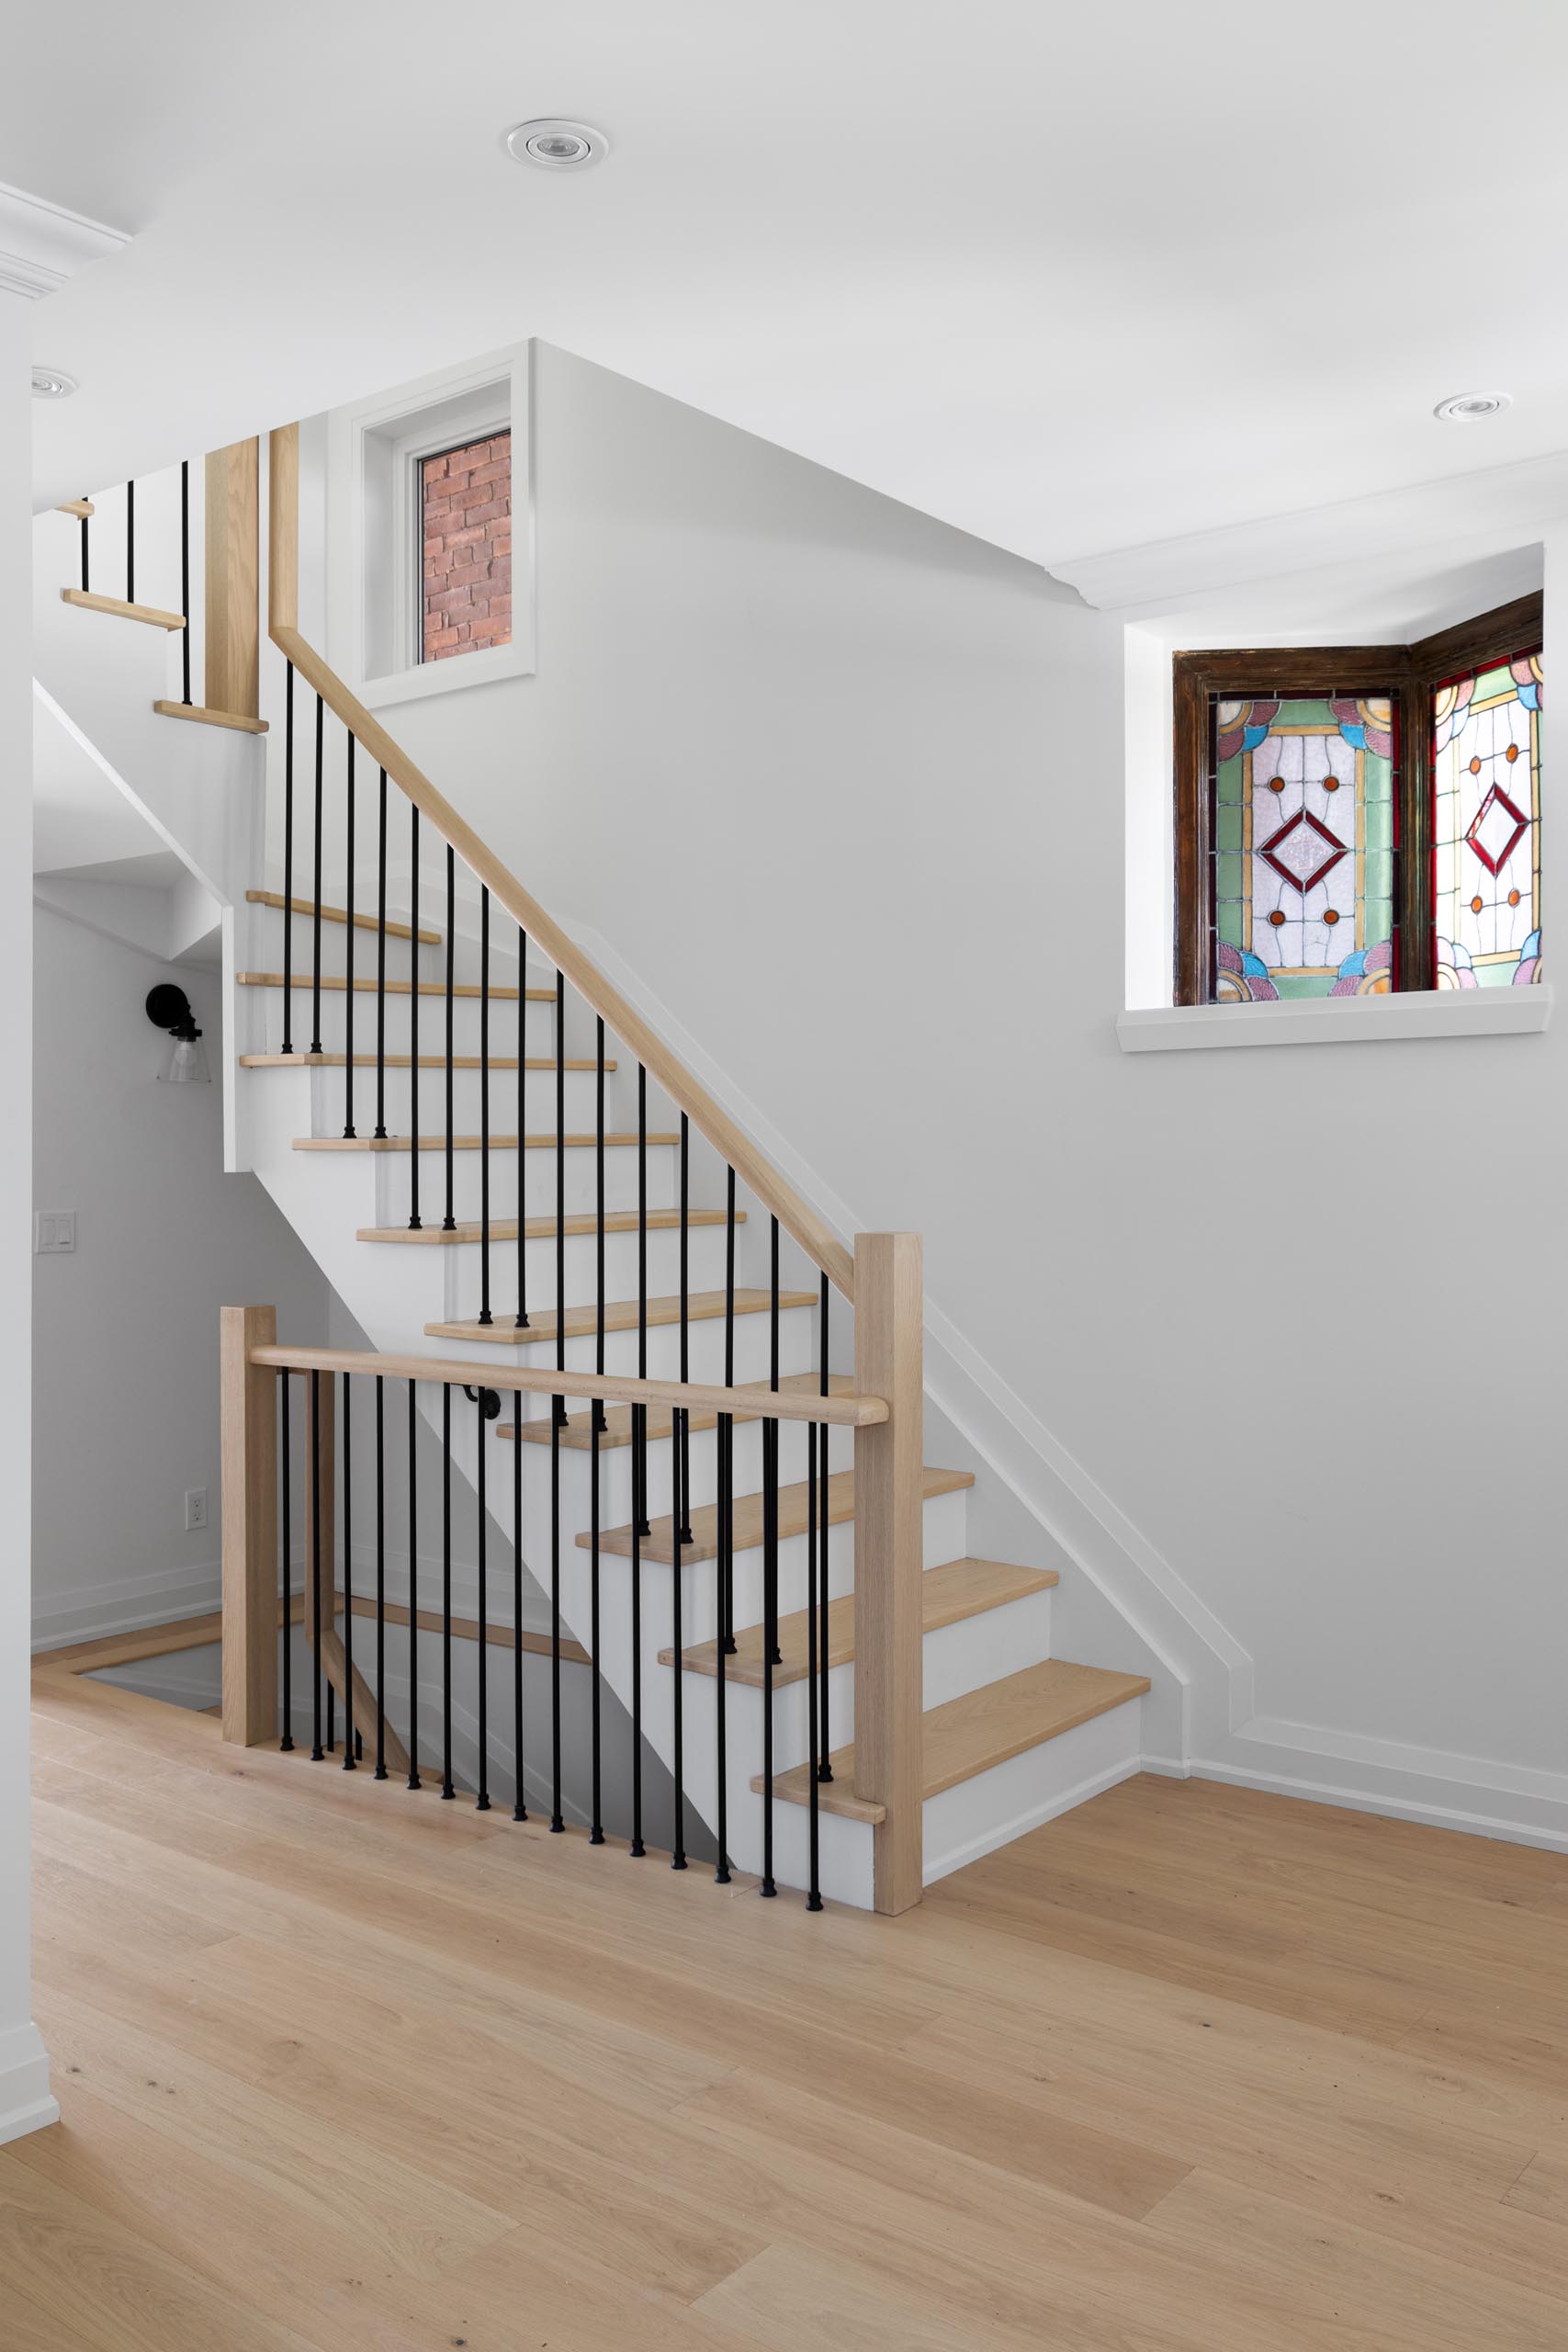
top-left (24, 908), bottom-right (329, 1646)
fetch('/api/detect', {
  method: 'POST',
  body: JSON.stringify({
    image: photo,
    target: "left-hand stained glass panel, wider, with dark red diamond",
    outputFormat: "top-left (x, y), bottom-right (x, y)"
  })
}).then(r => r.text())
top-left (1213, 696), bottom-right (1394, 1002)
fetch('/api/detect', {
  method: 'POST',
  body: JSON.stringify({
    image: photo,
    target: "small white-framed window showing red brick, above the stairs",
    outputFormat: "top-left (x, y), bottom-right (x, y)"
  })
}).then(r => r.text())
top-left (327, 350), bottom-right (534, 708)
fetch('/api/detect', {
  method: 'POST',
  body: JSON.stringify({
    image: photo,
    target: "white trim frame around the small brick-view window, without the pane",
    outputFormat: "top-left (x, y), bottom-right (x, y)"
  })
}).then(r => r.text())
top-left (327, 345), bottom-right (536, 710)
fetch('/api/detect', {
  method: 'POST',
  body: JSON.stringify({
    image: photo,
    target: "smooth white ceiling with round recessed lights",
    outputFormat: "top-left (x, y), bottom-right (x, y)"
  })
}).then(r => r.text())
top-left (12, 0), bottom-right (1568, 564)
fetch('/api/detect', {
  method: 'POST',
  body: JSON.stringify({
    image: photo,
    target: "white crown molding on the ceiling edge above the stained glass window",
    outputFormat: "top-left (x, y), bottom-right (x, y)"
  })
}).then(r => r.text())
top-left (1051, 449), bottom-right (1568, 612)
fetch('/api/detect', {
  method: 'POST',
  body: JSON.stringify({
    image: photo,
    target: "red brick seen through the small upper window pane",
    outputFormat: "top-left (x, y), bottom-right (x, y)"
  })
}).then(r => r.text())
top-left (419, 433), bottom-right (513, 661)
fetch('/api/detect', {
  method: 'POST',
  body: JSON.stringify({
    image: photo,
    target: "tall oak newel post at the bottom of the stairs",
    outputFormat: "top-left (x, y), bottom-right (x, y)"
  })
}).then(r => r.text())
top-left (856, 1232), bottom-right (924, 1912)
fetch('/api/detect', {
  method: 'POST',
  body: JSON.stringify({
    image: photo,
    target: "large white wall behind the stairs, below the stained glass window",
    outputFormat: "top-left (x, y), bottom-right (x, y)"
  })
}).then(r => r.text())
top-left (293, 348), bottom-right (1568, 1853)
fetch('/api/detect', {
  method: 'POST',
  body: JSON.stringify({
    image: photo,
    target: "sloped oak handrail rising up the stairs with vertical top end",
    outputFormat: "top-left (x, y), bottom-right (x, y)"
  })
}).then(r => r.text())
top-left (268, 425), bottom-right (856, 1307)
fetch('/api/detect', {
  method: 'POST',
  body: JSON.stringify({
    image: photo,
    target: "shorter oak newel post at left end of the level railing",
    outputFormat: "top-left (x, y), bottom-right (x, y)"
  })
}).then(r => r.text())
top-left (219, 1307), bottom-right (277, 1747)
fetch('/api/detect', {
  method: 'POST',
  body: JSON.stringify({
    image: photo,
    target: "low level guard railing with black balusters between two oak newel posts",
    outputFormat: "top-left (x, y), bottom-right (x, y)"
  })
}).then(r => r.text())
top-left (221, 1307), bottom-right (921, 1910)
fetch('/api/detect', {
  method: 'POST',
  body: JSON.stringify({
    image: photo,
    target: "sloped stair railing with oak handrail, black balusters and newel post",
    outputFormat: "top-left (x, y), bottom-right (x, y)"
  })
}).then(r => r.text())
top-left (191, 425), bottom-right (940, 1910)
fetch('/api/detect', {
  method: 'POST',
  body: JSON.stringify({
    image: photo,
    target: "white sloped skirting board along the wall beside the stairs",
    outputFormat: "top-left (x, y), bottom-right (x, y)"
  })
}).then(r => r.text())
top-left (564, 903), bottom-right (1253, 1771)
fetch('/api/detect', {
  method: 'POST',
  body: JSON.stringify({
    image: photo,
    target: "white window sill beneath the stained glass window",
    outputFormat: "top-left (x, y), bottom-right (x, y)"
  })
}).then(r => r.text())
top-left (1117, 983), bottom-right (1551, 1054)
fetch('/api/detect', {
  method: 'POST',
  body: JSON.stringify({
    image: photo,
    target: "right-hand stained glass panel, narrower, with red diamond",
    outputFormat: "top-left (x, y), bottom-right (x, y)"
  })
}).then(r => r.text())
top-left (1432, 654), bottom-right (1542, 988)
